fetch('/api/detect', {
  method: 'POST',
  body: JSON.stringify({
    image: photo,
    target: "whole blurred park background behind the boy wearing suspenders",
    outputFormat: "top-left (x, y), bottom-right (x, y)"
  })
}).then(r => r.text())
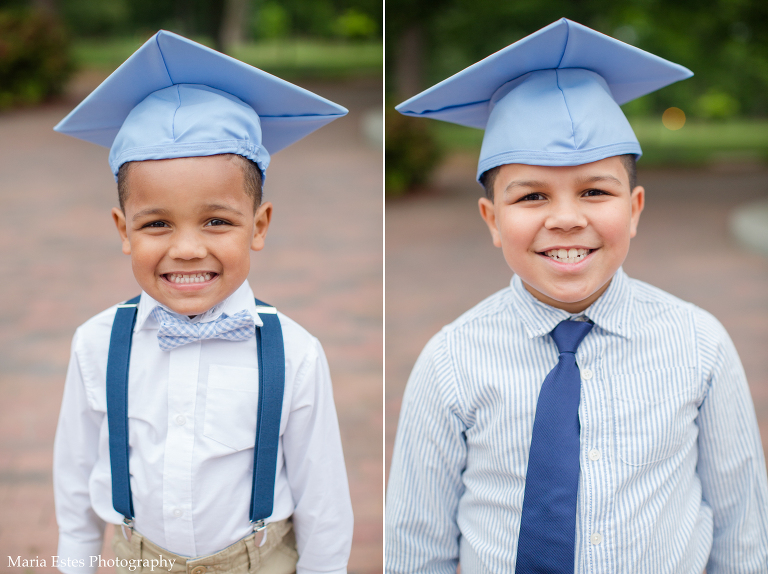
top-left (0, 0), bottom-right (383, 574)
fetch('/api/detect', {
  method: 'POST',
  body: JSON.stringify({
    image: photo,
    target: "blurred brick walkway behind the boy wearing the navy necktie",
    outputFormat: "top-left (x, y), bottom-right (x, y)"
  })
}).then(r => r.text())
top-left (385, 152), bottom-right (768, 486)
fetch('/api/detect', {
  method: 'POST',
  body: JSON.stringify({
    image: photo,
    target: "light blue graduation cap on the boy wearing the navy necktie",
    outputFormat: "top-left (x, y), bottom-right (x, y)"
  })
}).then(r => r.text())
top-left (396, 18), bottom-right (693, 180)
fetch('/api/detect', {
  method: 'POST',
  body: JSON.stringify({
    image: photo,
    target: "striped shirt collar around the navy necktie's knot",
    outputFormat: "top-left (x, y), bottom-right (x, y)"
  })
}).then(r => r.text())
top-left (510, 268), bottom-right (632, 339)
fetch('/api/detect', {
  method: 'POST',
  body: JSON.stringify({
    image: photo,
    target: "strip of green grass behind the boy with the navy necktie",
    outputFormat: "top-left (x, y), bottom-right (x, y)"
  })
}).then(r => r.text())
top-left (430, 118), bottom-right (768, 167)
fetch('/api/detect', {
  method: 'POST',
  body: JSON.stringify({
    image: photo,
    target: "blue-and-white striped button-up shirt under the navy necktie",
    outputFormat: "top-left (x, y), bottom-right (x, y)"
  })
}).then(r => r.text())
top-left (386, 270), bottom-right (768, 574)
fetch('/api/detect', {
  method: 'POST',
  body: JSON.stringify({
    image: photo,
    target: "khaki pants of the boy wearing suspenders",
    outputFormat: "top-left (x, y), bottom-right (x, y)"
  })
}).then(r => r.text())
top-left (112, 519), bottom-right (299, 574)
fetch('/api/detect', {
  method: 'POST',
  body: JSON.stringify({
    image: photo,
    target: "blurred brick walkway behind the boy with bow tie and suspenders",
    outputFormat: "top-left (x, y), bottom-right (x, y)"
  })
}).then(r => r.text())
top-left (0, 82), bottom-right (382, 574)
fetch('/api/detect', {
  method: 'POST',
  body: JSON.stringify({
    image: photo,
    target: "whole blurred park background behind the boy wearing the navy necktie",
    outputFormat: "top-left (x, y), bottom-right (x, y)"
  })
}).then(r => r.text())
top-left (385, 0), bottom-right (768, 496)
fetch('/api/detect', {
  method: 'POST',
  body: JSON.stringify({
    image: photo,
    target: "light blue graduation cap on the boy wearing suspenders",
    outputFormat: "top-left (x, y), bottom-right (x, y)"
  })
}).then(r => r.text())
top-left (54, 30), bottom-right (347, 177)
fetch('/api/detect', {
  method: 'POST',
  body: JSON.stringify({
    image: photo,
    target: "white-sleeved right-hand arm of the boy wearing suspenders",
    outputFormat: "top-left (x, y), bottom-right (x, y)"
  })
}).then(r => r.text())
top-left (283, 338), bottom-right (353, 574)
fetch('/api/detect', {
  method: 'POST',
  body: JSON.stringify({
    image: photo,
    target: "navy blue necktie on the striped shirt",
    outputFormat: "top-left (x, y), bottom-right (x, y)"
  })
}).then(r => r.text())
top-left (515, 321), bottom-right (592, 574)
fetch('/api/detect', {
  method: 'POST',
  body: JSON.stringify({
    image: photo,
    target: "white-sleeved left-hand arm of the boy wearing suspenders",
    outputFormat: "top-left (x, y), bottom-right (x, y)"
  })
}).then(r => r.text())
top-left (53, 333), bottom-right (105, 574)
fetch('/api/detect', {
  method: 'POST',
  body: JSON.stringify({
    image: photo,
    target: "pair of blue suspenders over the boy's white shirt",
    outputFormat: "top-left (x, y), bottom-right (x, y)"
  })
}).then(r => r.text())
top-left (107, 297), bottom-right (285, 530)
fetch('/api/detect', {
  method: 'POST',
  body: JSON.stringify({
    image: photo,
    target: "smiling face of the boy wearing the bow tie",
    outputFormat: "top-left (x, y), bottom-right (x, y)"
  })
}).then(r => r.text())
top-left (112, 155), bottom-right (272, 316)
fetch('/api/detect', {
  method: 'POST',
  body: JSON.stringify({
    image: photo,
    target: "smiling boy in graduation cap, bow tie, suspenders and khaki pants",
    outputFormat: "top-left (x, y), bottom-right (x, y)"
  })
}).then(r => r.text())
top-left (54, 31), bottom-right (352, 574)
